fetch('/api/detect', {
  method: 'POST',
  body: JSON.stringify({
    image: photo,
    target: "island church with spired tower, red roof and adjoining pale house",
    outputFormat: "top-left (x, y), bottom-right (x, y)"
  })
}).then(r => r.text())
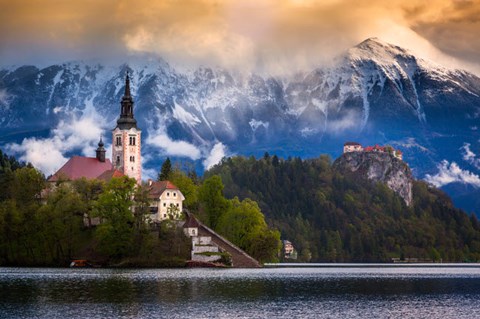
top-left (48, 73), bottom-right (185, 221)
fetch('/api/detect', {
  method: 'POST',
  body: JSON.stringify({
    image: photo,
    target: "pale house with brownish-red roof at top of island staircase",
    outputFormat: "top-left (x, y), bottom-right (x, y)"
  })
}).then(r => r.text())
top-left (148, 180), bottom-right (185, 222)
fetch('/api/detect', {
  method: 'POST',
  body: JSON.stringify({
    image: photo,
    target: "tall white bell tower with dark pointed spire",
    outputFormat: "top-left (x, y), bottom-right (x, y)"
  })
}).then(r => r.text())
top-left (112, 73), bottom-right (142, 184)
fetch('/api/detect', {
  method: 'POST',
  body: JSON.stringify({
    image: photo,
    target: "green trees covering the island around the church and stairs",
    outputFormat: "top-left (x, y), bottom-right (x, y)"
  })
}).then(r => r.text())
top-left (0, 151), bottom-right (280, 267)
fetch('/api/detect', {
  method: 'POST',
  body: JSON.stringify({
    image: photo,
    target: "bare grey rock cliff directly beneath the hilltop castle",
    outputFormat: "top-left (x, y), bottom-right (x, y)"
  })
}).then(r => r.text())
top-left (333, 152), bottom-right (413, 206)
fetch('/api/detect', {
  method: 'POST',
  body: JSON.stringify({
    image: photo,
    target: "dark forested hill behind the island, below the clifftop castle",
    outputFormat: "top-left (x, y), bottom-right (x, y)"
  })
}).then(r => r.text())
top-left (206, 154), bottom-right (480, 262)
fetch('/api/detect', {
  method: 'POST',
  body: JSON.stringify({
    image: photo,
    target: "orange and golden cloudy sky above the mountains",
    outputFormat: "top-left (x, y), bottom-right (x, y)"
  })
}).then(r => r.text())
top-left (0, 0), bottom-right (480, 74)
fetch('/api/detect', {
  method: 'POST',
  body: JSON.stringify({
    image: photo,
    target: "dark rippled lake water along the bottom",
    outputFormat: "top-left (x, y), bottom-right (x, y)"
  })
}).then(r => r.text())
top-left (0, 267), bottom-right (480, 319)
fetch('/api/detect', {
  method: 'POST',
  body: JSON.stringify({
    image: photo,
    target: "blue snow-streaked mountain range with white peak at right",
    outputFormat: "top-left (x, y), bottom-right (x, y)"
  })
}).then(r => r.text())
top-left (0, 38), bottom-right (480, 212)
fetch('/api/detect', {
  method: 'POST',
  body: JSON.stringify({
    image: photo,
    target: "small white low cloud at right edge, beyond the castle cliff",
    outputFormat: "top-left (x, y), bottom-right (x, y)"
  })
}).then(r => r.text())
top-left (424, 160), bottom-right (480, 187)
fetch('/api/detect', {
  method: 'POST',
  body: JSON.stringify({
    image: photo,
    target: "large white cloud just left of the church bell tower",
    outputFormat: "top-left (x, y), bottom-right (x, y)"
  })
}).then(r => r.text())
top-left (6, 114), bottom-right (105, 175)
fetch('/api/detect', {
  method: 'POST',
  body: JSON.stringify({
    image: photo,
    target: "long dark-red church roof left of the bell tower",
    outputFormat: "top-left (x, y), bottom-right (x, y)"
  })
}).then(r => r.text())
top-left (48, 156), bottom-right (113, 182)
